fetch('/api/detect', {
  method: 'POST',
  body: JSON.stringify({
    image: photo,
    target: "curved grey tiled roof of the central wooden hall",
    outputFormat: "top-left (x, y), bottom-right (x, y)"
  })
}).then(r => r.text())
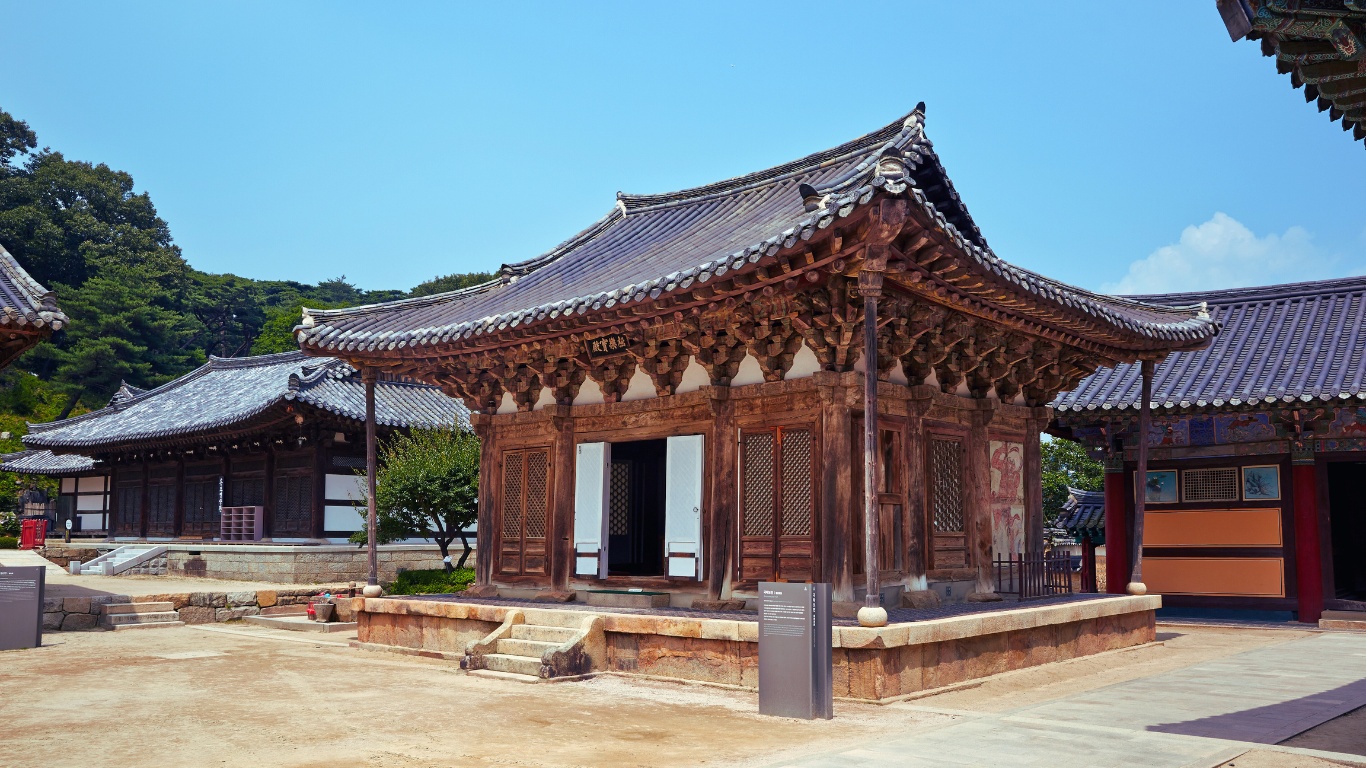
top-left (295, 105), bottom-right (1216, 359)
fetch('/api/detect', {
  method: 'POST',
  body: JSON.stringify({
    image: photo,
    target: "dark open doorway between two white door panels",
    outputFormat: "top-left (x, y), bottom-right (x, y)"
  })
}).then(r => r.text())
top-left (607, 440), bottom-right (668, 575)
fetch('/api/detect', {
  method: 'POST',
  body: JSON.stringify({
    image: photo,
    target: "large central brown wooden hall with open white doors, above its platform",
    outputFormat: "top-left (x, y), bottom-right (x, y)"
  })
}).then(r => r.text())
top-left (296, 105), bottom-right (1217, 612)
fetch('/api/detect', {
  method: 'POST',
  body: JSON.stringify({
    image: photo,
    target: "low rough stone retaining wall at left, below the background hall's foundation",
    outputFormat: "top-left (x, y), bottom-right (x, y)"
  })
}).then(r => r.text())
top-left (42, 585), bottom-right (352, 631)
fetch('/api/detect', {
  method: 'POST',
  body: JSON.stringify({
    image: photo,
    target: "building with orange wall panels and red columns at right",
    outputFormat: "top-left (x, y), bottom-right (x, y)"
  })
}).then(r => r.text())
top-left (1052, 277), bottom-right (1366, 622)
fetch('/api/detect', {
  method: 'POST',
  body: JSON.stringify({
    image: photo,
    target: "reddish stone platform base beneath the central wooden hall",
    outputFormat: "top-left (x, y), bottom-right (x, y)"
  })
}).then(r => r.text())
top-left (352, 596), bottom-right (1161, 701)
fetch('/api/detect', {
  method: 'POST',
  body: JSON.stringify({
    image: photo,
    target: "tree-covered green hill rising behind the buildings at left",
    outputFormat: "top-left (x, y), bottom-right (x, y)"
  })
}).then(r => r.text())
top-left (0, 109), bottom-right (492, 420)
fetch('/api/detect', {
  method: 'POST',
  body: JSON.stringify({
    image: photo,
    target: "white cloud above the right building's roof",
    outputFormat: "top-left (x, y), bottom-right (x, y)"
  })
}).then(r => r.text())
top-left (1101, 213), bottom-right (1339, 295)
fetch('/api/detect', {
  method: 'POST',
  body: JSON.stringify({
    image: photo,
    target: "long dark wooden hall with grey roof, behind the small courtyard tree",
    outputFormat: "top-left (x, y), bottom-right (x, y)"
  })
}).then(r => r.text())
top-left (0, 351), bottom-right (467, 543)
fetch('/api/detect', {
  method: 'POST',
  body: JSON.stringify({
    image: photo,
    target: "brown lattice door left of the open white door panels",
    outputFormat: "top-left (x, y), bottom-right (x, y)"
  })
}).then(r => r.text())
top-left (499, 450), bottom-right (550, 575)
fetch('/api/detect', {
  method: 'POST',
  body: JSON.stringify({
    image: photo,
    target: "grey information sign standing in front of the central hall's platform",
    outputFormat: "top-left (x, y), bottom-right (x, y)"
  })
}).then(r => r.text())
top-left (759, 582), bottom-right (835, 720)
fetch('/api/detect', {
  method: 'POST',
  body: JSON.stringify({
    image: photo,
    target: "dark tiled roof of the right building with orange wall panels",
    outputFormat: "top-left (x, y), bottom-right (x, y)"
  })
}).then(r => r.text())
top-left (1052, 271), bottom-right (1366, 411)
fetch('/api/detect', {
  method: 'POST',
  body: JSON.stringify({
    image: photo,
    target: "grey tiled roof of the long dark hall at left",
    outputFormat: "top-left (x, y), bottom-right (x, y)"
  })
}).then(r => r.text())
top-left (23, 351), bottom-right (469, 451)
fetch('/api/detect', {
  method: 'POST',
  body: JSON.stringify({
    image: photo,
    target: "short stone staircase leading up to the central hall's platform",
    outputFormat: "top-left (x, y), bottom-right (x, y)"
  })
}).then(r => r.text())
top-left (467, 608), bottom-right (594, 683)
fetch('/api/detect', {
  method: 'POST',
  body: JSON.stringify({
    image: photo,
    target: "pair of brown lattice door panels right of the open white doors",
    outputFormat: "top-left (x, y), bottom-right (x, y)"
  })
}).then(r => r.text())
top-left (739, 426), bottom-right (816, 582)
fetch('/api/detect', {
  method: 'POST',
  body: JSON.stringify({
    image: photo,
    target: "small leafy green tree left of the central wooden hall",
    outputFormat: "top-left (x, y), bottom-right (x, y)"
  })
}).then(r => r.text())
top-left (351, 429), bottom-right (479, 571)
